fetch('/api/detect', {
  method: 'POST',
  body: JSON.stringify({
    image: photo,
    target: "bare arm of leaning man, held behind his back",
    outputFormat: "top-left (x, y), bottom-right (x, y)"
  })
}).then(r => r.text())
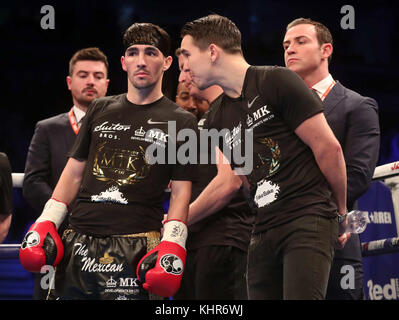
top-left (295, 113), bottom-right (346, 214)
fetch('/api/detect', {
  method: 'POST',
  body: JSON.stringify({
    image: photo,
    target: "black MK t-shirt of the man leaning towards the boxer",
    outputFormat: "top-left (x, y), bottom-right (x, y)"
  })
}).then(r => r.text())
top-left (219, 66), bottom-right (336, 233)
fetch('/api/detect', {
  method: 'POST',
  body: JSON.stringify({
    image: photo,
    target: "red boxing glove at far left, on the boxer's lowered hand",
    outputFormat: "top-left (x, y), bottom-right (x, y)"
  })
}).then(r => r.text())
top-left (19, 220), bottom-right (64, 272)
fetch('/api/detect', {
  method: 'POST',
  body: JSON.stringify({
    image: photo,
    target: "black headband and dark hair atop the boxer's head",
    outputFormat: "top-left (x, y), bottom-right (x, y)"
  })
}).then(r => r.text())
top-left (123, 23), bottom-right (171, 57)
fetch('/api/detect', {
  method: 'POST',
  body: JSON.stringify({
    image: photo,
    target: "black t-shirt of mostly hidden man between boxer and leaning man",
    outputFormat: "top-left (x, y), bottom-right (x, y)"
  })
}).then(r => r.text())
top-left (186, 95), bottom-right (254, 251)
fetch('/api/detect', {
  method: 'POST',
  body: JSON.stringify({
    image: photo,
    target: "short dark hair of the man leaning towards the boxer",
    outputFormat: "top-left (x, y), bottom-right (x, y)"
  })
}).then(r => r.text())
top-left (180, 14), bottom-right (242, 55)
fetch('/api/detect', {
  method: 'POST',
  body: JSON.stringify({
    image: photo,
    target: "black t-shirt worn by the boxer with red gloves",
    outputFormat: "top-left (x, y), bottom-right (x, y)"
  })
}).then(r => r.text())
top-left (70, 94), bottom-right (197, 235)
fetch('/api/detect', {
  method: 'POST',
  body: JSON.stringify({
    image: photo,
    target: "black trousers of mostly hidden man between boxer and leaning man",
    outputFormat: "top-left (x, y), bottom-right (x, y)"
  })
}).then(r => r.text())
top-left (174, 246), bottom-right (247, 300)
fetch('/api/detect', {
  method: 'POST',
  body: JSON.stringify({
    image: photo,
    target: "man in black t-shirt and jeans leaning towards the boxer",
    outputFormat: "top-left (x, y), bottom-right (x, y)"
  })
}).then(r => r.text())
top-left (181, 15), bottom-right (347, 299)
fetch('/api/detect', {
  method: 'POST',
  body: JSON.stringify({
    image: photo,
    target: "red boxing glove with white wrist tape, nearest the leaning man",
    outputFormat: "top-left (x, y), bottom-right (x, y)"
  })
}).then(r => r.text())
top-left (136, 220), bottom-right (187, 297)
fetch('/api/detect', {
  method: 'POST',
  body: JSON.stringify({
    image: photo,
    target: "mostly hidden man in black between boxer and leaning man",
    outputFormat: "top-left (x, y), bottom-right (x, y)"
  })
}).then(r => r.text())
top-left (174, 50), bottom-right (254, 300)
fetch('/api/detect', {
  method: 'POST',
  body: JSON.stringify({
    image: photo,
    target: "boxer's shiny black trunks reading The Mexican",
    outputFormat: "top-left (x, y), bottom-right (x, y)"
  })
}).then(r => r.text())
top-left (47, 229), bottom-right (163, 300)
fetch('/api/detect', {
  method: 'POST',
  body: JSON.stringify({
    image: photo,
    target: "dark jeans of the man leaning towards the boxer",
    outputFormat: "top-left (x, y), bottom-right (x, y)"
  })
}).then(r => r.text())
top-left (247, 215), bottom-right (338, 300)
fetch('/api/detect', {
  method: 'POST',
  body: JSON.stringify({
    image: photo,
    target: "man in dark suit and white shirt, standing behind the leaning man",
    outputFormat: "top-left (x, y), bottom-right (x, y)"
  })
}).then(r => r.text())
top-left (283, 18), bottom-right (380, 300)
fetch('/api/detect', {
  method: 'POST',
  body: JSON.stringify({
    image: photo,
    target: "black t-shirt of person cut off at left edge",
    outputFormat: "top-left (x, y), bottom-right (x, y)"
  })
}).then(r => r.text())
top-left (0, 152), bottom-right (13, 216)
